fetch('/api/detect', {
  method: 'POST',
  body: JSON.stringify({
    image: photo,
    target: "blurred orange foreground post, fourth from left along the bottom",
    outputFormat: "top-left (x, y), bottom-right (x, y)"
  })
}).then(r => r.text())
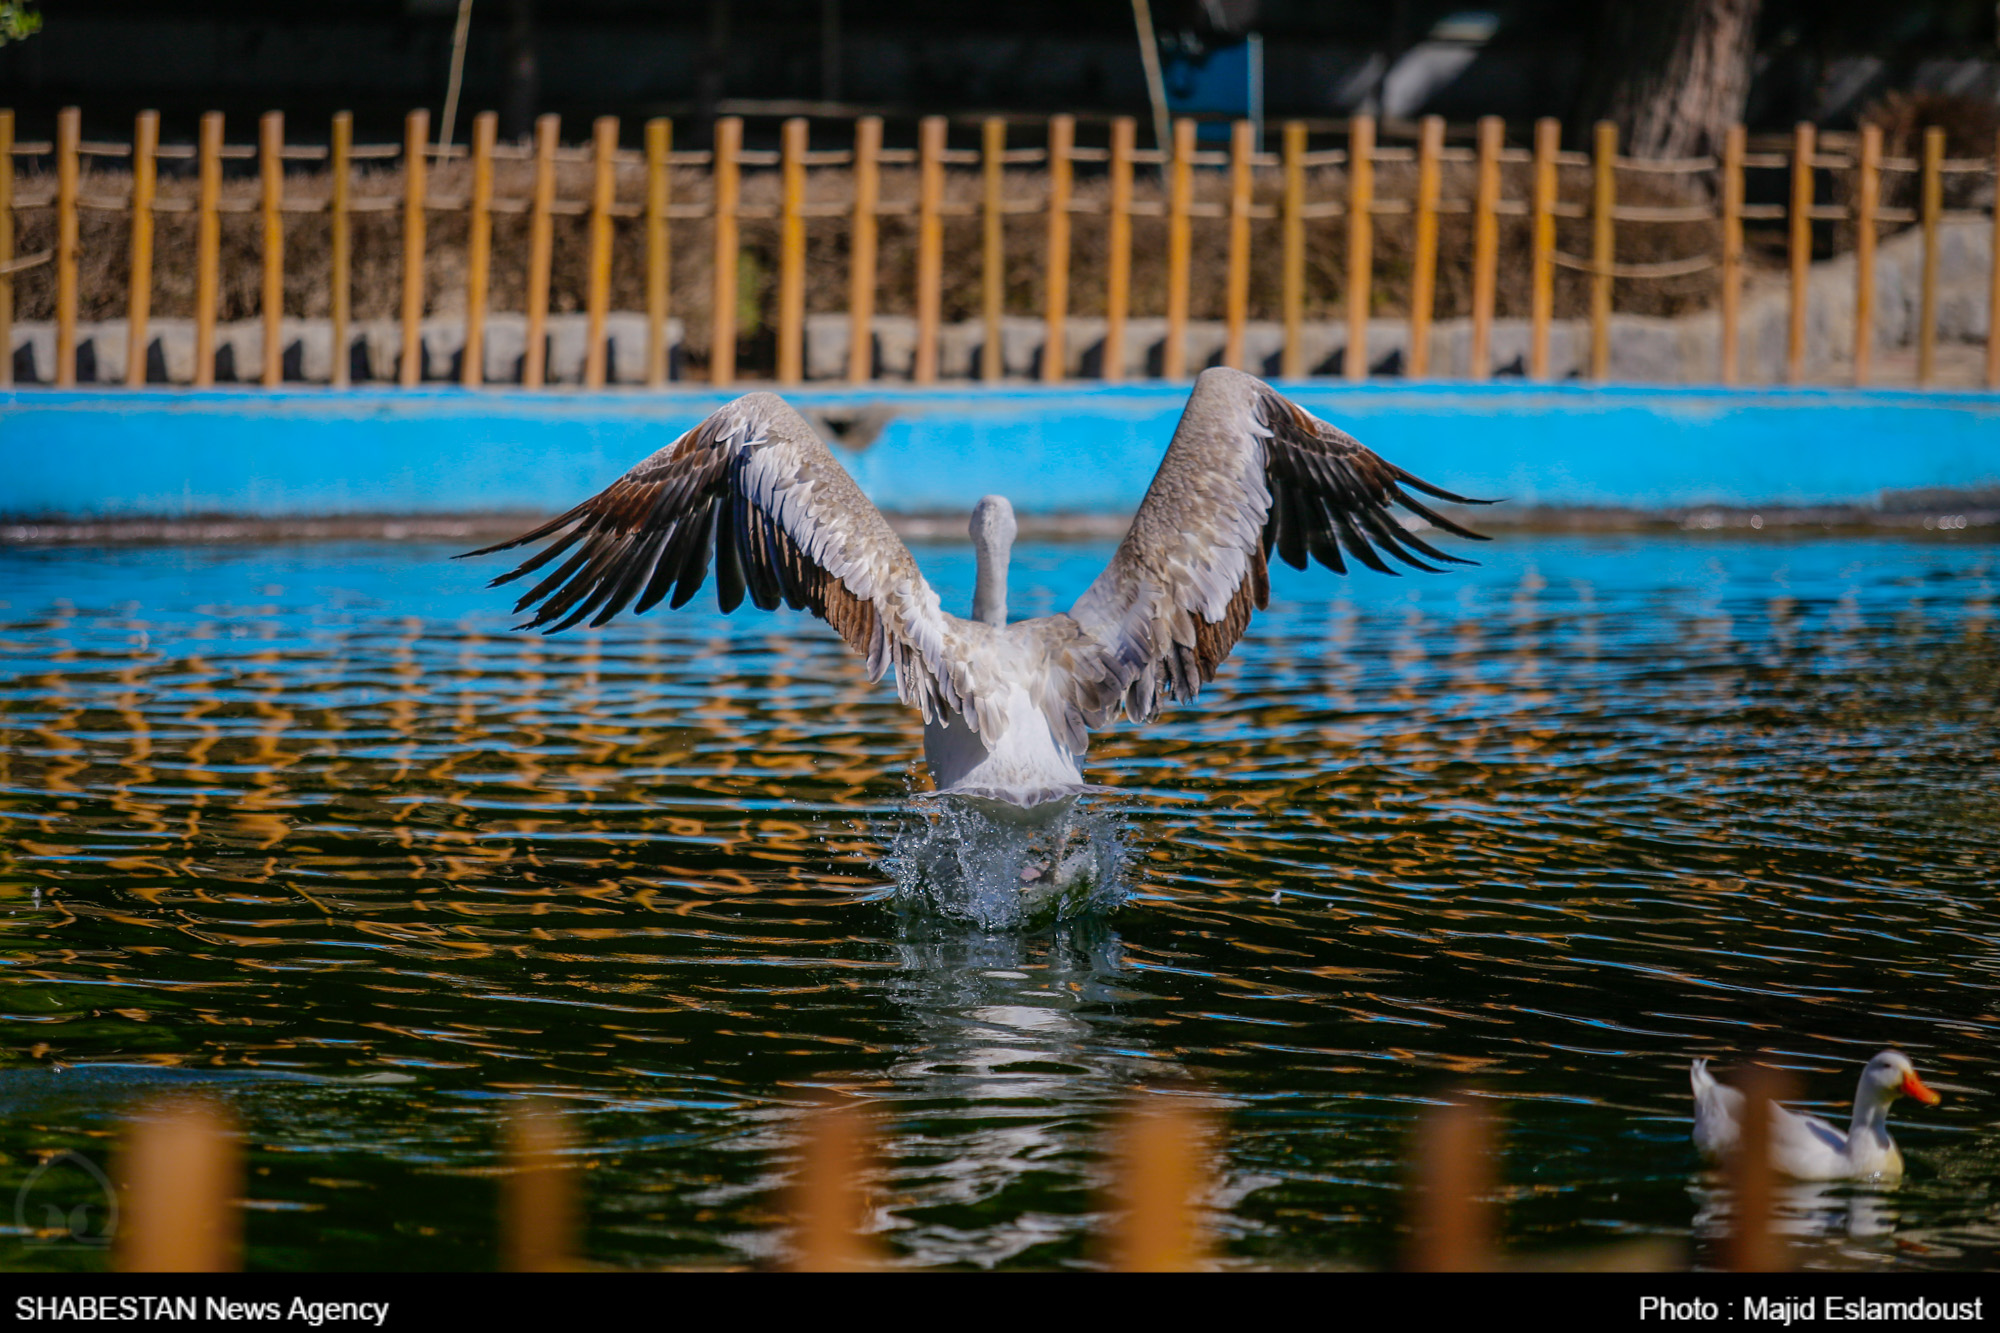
top-left (1106, 1097), bottom-right (1212, 1273)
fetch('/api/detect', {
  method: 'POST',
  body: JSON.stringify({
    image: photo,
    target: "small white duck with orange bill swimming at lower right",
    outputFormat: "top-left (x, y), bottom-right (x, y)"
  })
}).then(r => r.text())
top-left (1690, 1051), bottom-right (1938, 1181)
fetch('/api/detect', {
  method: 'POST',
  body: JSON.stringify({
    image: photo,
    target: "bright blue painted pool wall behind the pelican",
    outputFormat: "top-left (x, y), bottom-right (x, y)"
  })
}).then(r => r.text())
top-left (0, 382), bottom-right (2000, 518)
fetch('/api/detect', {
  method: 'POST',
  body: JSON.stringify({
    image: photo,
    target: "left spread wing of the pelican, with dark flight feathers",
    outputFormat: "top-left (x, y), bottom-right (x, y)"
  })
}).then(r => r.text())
top-left (454, 394), bottom-right (980, 727)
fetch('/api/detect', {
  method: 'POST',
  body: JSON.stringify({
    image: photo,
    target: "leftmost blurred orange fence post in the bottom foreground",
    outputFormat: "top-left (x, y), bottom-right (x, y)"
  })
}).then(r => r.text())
top-left (112, 1099), bottom-right (242, 1273)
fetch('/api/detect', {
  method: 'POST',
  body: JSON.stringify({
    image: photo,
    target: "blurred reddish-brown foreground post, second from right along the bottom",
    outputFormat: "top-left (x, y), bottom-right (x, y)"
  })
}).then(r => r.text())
top-left (1404, 1099), bottom-right (1496, 1273)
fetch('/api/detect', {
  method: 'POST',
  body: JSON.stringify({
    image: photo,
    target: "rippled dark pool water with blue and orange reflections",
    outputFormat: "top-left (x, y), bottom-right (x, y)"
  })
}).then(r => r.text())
top-left (0, 536), bottom-right (2000, 1267)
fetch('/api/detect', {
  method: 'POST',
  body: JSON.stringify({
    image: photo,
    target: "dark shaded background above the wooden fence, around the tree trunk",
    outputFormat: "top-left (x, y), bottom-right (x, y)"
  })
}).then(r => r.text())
top-left (0, 0), bottom-right (2000, 140)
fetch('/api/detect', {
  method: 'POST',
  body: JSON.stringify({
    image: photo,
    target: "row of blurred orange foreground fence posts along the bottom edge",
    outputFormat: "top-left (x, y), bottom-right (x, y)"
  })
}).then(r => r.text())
top-left (101, 1065), bottom-right (1824, 1273)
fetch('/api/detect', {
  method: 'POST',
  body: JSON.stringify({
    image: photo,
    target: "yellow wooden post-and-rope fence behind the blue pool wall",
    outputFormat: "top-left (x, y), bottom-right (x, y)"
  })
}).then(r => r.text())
top-left (0, 108), bottom-right (2000, 388)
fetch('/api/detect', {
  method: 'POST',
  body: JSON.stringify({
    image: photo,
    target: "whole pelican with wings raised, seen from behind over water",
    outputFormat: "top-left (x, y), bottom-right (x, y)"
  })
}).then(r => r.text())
top-left (466, 368), bottom-right (1486, 813)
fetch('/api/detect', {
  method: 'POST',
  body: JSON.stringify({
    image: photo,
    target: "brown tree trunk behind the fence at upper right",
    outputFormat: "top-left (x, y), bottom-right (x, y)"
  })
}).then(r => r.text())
top-left (1578, 0), bottom-right (1762, 158)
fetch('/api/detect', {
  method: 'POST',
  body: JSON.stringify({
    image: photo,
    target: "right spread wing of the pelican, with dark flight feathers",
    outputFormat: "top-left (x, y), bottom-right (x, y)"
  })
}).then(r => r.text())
top-left (1070, 368), bottom-right (1486, 725)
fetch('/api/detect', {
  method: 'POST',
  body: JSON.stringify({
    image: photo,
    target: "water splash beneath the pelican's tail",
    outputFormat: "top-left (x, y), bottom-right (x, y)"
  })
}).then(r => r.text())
top-left (882, 797), bottom-right (1128, 931)
